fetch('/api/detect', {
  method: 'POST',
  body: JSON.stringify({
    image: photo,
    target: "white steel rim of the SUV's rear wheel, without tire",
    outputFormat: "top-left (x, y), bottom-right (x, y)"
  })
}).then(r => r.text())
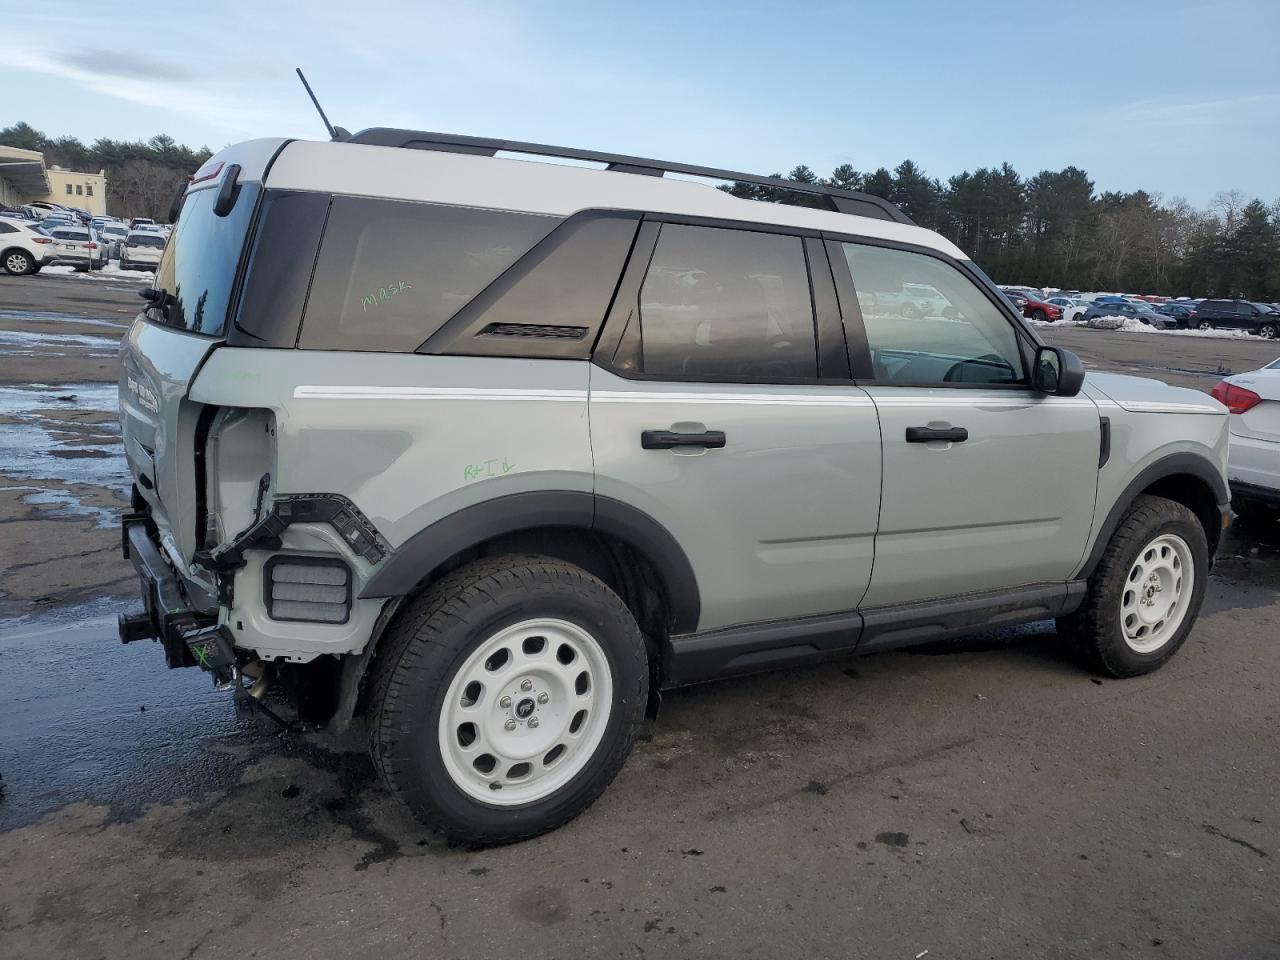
top-left (439, 618), bottom-right (613, 806)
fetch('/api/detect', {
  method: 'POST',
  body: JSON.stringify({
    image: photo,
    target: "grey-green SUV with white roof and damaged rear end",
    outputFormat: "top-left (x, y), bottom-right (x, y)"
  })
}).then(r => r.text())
top-left (120, 128), bottom-right (1229, 844)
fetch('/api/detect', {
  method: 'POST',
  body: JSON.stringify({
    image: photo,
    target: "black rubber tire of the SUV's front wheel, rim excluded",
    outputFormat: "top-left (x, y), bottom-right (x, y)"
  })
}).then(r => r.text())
top-left (1057, 495), bottom-right (1208, 677)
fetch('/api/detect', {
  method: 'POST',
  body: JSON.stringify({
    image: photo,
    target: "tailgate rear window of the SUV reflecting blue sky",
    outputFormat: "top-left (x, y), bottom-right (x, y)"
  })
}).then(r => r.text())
top-left (149, 184), bottom-right (259, 337)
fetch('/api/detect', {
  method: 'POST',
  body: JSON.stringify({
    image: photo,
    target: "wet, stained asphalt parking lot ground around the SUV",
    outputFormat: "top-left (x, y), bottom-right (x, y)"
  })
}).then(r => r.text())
top-left (0, 275), bottom-right (1280, 960)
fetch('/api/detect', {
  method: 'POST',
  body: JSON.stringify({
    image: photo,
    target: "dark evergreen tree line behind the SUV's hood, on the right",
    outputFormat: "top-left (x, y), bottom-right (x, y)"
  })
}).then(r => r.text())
top-left (723, 160), bottom-right (1280, 302)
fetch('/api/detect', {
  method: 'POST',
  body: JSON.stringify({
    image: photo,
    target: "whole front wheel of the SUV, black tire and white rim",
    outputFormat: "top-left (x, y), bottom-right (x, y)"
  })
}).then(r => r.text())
top-left (1059, 495), bottom-right (1208, 677)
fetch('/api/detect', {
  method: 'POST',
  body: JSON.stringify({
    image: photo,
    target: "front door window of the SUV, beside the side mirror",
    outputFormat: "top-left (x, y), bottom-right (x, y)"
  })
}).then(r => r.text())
top-left (841, 243), bottom-right (1023, 383)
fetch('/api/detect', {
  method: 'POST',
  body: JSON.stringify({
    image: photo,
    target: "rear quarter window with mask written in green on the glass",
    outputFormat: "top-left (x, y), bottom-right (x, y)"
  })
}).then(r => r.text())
top-left (298, 197), bottom-right (561, 352)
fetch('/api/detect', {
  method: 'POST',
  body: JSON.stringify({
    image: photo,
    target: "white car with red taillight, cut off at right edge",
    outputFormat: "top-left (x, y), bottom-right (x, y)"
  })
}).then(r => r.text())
top-left (1212, 360), bottom-right (1280, 520)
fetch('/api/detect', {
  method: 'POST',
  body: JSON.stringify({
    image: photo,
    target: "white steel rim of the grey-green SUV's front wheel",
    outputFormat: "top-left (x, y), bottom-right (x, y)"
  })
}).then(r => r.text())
top-left (1120, 534), bottom-right (1196, 653)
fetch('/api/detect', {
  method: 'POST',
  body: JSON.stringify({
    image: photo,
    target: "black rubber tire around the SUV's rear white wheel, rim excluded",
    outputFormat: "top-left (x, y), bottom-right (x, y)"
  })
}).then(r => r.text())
top-left (366, 557), bottom-right (649, 846)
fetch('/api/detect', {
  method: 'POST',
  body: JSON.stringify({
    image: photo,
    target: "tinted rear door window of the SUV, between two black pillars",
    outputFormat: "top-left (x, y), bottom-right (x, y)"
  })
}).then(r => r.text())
top-left (640, 224), bottom-right (818, 380)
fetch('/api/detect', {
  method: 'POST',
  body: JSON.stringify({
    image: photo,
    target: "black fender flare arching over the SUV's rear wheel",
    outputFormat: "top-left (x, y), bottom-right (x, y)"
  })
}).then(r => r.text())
top-left (360, 490), bottom-right (701, 634)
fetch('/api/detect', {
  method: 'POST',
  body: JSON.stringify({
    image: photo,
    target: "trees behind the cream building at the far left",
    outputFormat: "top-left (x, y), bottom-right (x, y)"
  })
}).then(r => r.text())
top-left (0, 122), bottom-right (210, 223)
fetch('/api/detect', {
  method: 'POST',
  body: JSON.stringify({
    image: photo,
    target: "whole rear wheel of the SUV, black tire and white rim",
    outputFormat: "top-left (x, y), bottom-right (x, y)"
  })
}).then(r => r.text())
top-left (367, 557), bottom-right (649, 845)
